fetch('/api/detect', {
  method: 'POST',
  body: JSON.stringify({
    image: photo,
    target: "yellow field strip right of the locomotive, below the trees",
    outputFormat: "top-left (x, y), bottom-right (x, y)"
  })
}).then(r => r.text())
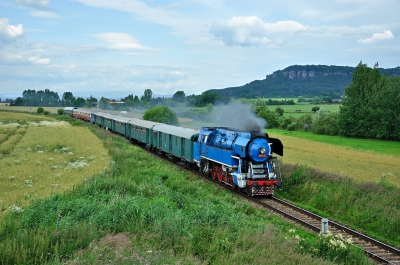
top-left (269, 130), bottom-right (400, 187)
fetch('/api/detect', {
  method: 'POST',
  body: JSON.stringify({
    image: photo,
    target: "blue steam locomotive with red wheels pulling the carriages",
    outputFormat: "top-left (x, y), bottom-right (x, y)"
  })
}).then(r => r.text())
top-left (194, 127), bottom-right (283, 196)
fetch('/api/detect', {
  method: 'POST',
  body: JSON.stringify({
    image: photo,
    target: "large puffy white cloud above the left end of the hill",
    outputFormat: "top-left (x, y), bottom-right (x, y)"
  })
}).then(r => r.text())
top-left (210, 16), bottom-right (306, 46)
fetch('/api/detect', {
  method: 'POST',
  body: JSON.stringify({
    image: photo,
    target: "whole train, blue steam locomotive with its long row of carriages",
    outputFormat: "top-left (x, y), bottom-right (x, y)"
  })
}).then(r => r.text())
top-left (72, 109), bottom-right (283, 196)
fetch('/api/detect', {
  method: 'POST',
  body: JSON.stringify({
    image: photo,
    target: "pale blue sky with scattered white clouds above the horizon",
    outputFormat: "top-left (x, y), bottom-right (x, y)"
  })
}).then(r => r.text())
top-left (0, 0), bottom-right (400, 100)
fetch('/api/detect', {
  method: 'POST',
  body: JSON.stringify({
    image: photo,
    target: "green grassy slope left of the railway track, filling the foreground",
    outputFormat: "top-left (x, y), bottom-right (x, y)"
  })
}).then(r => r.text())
top-left (0, 112), bottom-right (368, 264)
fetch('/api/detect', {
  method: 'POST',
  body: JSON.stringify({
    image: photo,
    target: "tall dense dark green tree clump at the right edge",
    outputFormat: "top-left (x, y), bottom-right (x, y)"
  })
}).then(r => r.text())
top-left (338, 62), bottom-right (400, 141)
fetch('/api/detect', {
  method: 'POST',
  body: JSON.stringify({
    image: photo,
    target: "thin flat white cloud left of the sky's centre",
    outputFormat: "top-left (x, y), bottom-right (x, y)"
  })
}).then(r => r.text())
top-left (91, 32), bottom-right (149, 50)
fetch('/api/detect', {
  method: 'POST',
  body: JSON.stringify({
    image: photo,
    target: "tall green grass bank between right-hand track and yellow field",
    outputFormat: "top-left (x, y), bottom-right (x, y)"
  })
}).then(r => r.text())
top-left (278, 165), bottom-right (400, 247)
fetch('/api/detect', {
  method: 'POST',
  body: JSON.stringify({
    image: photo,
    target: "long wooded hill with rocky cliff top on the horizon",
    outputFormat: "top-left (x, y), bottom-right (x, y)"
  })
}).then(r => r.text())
top-left (208, 65), bottom-right (400, 98)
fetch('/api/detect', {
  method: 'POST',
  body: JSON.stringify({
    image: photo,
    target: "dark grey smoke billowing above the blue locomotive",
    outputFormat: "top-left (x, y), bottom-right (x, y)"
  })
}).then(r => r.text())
top-left (210, 101), bottom-right (267, 132)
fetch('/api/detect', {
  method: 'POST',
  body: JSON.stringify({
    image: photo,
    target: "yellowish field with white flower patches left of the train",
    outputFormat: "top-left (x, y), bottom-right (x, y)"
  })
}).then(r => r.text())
top-left (0, 111), bottom-right (110, 211)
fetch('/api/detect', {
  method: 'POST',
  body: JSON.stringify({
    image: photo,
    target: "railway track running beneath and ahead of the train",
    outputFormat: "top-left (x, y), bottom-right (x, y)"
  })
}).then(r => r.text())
top-left (143, 139), bottom-right (400, 265)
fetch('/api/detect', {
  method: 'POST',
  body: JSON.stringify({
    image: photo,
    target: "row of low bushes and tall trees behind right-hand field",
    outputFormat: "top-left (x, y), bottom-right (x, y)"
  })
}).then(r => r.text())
top-left (253, 62), bottom-right (400, 141)
